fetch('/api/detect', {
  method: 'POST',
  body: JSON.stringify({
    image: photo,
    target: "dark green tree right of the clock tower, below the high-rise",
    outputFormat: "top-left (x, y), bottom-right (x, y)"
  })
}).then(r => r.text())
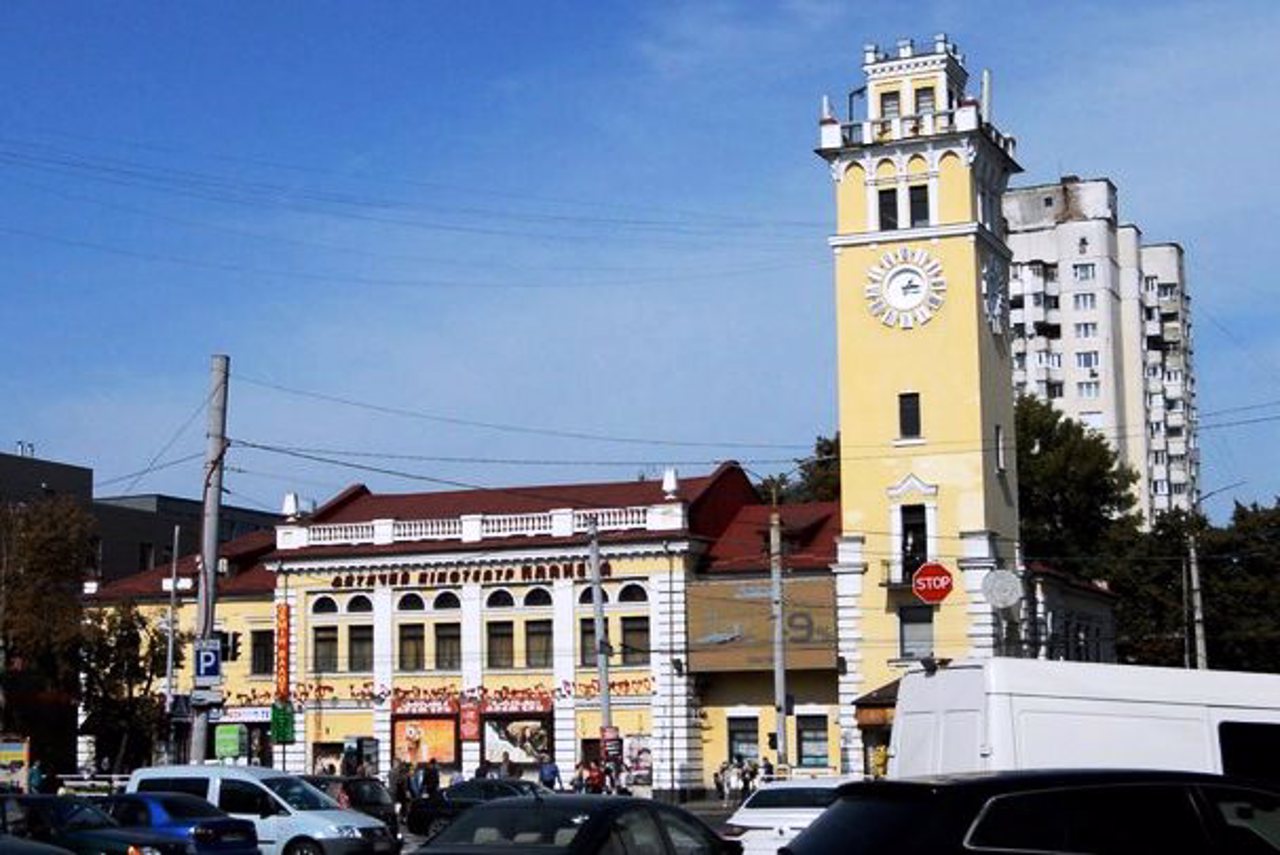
top-left (1015, 396), bottom-right (1139, 579)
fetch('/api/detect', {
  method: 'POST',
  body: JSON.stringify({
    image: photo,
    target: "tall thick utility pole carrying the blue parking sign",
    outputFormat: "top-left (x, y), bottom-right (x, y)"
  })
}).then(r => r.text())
top-left (191, 353), bottom-right (230, 763)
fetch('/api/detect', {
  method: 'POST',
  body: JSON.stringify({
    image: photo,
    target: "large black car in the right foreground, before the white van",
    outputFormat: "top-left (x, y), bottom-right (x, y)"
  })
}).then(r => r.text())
top-left (778, 769), bottom-right (1280, 855)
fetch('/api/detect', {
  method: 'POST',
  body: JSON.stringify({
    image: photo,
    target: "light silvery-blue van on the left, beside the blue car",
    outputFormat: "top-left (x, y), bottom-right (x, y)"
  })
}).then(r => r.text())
top-left (125, 765), bottom-right (399, 855)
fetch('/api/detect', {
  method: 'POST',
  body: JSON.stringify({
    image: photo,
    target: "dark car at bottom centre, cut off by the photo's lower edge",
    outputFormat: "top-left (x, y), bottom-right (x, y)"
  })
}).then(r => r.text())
top-left (419, 794), bottom-right (747, 855)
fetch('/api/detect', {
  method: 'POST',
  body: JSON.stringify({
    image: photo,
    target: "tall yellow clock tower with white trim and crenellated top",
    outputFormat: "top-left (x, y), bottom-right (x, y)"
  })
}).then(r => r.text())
top-left (818, 35), bottom-right (1020, 772)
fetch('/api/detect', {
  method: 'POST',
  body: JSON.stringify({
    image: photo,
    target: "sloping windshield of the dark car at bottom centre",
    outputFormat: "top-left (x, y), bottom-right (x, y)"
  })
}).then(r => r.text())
top-left (428, 801), bottom-right (591, 851)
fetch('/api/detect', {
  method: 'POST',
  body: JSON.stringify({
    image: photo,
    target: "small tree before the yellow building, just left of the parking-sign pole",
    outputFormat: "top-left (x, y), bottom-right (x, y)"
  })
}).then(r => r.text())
top-left (81, 603), bottom-right (186, 772)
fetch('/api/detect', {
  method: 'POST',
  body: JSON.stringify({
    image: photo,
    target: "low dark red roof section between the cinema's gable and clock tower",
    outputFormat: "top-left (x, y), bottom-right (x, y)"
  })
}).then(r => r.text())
top-left (707, 502), bottom-right (840, 572)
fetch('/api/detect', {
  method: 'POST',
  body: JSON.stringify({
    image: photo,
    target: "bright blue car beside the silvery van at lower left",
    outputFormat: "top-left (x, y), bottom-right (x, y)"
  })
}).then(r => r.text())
top-left (99, 792), bottom-right (259, 855)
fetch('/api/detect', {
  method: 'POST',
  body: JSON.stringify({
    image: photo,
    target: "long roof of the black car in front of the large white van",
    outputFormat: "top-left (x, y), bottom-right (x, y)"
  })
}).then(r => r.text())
top-left (838, 769), bottom-right (1256, 796)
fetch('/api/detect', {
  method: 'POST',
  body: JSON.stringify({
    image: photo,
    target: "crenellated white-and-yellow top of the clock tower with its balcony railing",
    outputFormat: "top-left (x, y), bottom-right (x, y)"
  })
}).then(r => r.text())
top-left (818, 33), bottom-right (1016, 159)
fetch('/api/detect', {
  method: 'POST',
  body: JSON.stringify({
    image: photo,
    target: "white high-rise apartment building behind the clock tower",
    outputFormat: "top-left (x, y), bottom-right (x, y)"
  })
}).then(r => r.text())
top-left (1004, 175), bottom-right (1199, 523)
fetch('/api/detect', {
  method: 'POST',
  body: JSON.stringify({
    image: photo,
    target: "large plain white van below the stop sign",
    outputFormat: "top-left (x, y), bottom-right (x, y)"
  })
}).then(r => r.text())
top-left (888, 658), bottom-right (1280, 781)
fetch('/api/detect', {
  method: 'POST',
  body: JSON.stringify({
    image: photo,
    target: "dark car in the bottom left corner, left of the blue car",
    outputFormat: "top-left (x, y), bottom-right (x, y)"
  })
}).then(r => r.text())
top-left (0, 796), bottom-right (187, 855)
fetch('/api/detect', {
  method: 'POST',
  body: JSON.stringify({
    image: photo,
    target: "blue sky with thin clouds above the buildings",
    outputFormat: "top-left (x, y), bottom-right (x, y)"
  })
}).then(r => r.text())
top-left (0, 0), bottom-right (1280, 518)
